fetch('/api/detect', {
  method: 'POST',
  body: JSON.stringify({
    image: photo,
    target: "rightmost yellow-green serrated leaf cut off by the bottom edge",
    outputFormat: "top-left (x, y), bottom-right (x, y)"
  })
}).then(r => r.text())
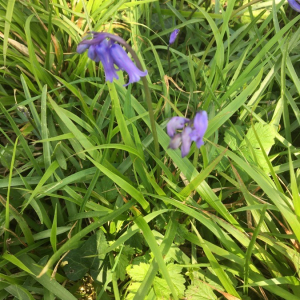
top-left (185, 280), bottom-right (217, 300)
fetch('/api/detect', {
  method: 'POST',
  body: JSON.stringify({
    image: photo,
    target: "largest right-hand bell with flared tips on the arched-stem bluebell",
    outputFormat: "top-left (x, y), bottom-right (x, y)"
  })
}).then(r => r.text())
top-left (110, 44), bottom-right (148, 86)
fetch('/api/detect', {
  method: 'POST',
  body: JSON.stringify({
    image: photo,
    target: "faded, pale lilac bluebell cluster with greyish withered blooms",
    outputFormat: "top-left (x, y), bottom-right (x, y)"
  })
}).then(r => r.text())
top-left (167, 110), bottom-right (208, 157)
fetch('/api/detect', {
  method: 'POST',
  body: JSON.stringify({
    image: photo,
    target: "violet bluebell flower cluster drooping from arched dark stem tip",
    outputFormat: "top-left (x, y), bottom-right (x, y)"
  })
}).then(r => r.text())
top-left (76, 32), bottom-right (147, 86)
